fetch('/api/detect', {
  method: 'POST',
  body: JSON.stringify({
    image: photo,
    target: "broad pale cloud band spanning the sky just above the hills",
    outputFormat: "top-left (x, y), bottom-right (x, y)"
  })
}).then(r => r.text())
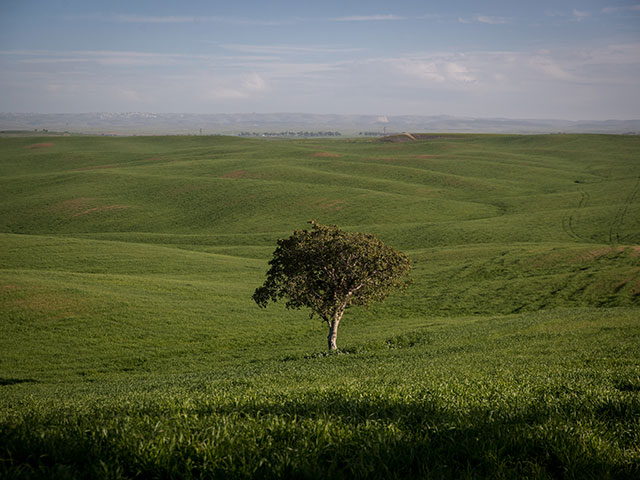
top-left (0, 42), bottom-right (640, 117)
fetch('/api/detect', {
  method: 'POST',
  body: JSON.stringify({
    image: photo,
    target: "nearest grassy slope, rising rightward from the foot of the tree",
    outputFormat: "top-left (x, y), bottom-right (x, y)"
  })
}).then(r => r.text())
top-left (0, 309), bottom-right (640, 479)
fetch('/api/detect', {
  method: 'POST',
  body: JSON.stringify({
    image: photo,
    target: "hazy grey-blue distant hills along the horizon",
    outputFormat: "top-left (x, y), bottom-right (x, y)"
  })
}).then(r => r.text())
top-left (0, 112), bottom-right (640, 135)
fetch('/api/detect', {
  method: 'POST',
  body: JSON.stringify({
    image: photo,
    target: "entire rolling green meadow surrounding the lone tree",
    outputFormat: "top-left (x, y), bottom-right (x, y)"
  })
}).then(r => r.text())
top-left (0, 135), bottom-right (640, 479)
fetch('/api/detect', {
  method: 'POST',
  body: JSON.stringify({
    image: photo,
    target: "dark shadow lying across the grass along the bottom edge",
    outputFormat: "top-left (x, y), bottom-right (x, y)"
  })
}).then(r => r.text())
top-left (0, 391), bottom-right (640, 479)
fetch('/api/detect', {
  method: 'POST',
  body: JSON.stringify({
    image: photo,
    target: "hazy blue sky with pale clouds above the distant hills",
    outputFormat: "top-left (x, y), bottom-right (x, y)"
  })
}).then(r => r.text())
top-left (0, 0), bottom-right (640, 120)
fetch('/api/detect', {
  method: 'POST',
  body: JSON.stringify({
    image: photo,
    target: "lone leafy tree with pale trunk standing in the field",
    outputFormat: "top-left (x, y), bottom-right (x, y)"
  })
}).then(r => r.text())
top-left (253, 220), bottom-right (411, 350)
